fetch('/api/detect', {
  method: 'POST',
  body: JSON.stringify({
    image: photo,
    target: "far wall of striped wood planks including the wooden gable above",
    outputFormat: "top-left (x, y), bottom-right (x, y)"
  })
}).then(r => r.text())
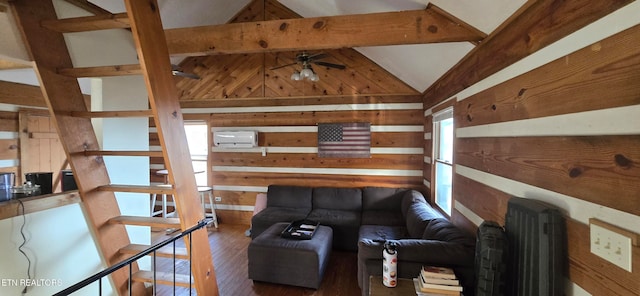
top-left (150, 1), bottom-right (425, 225)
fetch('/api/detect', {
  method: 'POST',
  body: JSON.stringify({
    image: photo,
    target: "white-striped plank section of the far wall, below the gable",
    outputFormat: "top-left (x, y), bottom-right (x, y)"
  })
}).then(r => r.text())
top-left (150, 95), bottom-right (426, 225)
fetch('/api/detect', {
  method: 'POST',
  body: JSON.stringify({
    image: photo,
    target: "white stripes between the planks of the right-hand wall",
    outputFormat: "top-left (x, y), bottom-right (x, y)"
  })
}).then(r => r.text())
top-left (426, 1), bottom-right (640, 295)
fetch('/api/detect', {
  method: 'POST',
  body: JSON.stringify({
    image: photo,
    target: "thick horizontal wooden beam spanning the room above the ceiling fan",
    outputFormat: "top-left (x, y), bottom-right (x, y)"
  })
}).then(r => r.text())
top-left (165, 7), bottom-right (486, 56)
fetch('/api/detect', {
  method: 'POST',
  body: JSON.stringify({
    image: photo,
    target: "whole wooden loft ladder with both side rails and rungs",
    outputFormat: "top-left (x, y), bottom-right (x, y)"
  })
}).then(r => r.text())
top-left (10, 0), bottom-right (218, 295)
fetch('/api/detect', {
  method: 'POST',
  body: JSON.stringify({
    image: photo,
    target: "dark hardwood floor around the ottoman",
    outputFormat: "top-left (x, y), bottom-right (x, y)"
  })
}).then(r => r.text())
top-left (152, 224), bottom-right (361, 296)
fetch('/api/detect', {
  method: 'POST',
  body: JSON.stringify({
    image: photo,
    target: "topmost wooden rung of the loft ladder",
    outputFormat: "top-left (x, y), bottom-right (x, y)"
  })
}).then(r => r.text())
top-left (40, 12), bottom-right (131, 33)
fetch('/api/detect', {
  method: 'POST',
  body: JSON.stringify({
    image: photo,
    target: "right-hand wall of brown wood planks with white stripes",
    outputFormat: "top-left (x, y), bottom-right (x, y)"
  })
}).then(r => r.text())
top-left (424, 17), bottom-right (640, 295)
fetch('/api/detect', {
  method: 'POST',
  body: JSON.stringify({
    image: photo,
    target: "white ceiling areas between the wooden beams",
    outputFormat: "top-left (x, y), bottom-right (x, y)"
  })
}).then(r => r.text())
top-left (0, 0), bottom-right (526, 92)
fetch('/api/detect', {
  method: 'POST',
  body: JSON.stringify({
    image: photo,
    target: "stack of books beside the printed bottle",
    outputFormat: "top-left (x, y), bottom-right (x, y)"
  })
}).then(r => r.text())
top-left (413, 266), bottom-right (462, 296)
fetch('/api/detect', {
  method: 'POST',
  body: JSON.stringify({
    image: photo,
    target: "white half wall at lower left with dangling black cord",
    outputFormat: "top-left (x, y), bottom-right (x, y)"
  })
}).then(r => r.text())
top-left (0, 204), bottom-right (111, 295)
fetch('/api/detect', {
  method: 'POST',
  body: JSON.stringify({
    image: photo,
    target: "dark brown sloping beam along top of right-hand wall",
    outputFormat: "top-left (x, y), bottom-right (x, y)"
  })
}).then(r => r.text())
top-left (423, 0), bottom-right (633, 108)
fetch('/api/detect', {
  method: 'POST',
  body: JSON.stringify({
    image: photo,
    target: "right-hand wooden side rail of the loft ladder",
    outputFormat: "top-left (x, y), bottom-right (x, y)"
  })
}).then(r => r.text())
top-left (124, 0), bottom-right (219, 295)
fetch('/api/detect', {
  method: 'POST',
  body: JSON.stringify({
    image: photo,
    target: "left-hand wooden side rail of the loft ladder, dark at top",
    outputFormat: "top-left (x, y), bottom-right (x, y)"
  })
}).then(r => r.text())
top-left (11, 0), bottom-right (145, 295)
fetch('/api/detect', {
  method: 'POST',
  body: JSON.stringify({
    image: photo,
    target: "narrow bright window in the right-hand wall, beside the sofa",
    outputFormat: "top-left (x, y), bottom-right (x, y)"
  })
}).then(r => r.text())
top-left (433, 108), bottom-right (454, 215)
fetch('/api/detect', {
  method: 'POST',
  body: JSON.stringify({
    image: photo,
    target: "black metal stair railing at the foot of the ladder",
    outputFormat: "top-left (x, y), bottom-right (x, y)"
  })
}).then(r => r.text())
top-left (53, 218), bottom-right (213, 296)
